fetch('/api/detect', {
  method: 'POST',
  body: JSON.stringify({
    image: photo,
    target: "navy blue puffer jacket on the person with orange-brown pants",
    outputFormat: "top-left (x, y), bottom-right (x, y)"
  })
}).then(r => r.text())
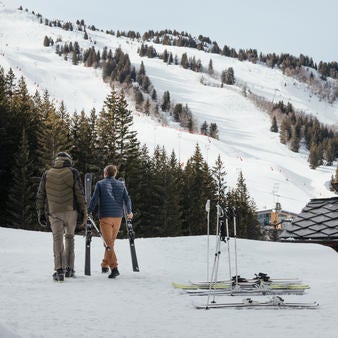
top-left (88, 177), bottom-right (132, 218)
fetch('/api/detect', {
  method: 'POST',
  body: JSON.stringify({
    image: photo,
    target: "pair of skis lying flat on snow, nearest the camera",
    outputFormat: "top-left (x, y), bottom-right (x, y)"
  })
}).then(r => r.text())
top-left (195, 296), bottom-right (319, 310)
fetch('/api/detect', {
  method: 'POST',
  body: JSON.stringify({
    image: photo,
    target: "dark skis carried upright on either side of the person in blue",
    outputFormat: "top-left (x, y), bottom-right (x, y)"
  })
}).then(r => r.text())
top-left (84, 173), bottom-right (140, 276)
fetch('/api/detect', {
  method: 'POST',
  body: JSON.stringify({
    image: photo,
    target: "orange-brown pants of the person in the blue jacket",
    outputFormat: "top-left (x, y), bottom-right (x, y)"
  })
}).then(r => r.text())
top-left (100, 217), bottom-right (122, 269)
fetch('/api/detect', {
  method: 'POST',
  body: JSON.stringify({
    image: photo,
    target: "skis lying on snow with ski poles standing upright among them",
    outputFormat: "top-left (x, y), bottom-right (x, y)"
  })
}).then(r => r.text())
top-left (172, 202), bottom-right (319, 309)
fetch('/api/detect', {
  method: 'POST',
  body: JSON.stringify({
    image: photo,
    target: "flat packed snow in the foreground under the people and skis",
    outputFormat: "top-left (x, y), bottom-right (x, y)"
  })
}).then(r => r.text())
top-left (0, 228), bottom-right (338, 338)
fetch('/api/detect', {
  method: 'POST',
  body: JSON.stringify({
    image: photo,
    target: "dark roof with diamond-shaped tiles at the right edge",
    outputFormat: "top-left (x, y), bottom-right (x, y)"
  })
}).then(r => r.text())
top-left (279, 197), bottom-right (338, 242)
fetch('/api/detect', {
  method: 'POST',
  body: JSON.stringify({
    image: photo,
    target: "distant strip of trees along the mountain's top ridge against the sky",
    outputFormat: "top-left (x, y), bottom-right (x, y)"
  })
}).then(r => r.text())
top-left (19, 6), bottom-right (338, 102)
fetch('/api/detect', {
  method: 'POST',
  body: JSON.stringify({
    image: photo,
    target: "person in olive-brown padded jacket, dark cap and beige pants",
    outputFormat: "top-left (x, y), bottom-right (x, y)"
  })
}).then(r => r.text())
top-left (36, 152), bottom-right (87, 281)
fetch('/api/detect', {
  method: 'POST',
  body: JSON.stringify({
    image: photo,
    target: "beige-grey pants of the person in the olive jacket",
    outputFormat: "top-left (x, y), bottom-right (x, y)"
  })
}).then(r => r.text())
top-left (49, 210), bottom-right (77, 270)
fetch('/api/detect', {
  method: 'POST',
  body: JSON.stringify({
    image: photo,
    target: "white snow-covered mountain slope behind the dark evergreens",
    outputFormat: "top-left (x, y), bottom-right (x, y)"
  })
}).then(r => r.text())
top-left (0, 4), bottom-right (338, 212)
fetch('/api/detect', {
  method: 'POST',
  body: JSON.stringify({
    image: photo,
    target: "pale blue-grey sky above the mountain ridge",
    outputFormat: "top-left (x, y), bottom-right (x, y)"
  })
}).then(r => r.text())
top-left (4, 0), bottom-right (338, 62)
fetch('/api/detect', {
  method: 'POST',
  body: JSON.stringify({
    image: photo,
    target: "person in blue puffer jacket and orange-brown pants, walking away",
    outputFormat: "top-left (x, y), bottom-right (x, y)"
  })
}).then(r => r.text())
top-left (88, 164), bottom-right (133, 278)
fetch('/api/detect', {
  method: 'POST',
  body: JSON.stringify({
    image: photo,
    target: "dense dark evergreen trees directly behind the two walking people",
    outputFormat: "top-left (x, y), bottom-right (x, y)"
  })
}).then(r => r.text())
top-left (0, 68), bottom-right (260, 238)
